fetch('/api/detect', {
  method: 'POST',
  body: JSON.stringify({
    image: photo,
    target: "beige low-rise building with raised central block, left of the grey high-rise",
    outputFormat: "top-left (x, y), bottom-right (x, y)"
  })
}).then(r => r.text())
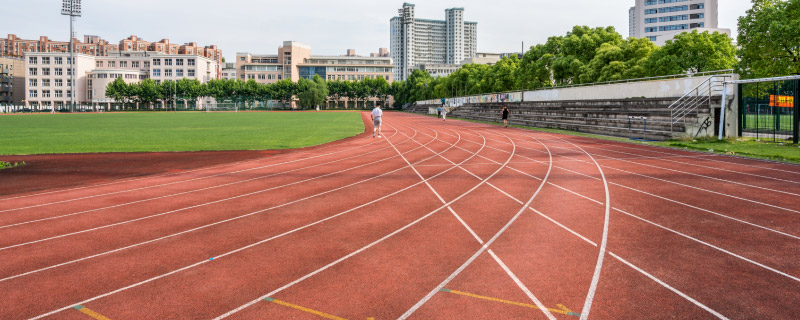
top-left (236, 41), bottom-right (394, 83)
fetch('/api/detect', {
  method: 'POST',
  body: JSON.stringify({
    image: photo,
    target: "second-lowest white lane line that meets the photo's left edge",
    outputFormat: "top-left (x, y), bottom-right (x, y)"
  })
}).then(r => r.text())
top-left (0, 129), bottom-right (434, 251)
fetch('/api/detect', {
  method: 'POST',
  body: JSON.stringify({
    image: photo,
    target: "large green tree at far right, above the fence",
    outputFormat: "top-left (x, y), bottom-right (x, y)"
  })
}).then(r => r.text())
top-left (737, 0), bottom-right (800, 78)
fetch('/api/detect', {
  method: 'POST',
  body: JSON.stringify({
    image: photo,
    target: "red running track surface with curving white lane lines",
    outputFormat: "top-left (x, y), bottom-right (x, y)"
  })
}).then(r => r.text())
top-left (0, 113), bottom-right (800, 319)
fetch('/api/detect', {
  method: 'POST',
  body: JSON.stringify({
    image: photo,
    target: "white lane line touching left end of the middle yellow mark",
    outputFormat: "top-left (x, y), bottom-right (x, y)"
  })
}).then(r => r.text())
top-left (214, 124), bottom-right (511, 320)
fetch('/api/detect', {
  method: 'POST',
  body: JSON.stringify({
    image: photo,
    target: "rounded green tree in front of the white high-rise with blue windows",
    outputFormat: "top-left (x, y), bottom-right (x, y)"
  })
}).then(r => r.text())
top-left (644, 30), bottom-right (736, 76)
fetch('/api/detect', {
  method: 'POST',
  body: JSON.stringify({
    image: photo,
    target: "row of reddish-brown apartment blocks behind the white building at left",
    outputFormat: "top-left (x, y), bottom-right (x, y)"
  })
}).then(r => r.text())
top-left (0, 34), bottom-right (222, 63)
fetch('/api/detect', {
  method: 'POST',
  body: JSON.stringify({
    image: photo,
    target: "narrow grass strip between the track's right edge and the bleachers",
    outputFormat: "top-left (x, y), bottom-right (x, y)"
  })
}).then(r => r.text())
top-left (429, 115), bottom-right (800, 163)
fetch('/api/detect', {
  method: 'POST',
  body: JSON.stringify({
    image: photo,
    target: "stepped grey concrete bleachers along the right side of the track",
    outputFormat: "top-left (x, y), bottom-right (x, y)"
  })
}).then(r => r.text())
top-left (406, 97), bottom-right (720, 140)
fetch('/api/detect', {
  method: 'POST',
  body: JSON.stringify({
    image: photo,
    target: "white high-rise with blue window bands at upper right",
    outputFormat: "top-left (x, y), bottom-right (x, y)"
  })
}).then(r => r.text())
top-left (628, 0), bottom-right (730, 45)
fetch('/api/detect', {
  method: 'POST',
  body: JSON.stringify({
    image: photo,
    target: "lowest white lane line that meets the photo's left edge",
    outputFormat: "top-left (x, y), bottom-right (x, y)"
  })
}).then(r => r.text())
top-left (0, 129), bottom-right (433, 282)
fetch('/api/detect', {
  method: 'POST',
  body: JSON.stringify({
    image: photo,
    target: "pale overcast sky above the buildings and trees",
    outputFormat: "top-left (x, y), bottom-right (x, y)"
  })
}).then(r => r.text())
top-left (0, 0), bottom-right (751, 61)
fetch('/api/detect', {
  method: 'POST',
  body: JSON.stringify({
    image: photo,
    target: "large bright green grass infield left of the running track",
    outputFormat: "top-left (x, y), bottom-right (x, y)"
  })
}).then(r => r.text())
top-left (0, 112), bottom-right (364, 155)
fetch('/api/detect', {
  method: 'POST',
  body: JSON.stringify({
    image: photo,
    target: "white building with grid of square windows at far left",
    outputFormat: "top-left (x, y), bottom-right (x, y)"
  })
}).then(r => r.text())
top-left (23, 51), bottom-right (219, 109)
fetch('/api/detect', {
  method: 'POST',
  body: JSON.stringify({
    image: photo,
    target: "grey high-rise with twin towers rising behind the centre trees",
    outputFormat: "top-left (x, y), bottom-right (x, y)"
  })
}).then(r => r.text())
top-left (389, 3), bottom-right (478, 80)
